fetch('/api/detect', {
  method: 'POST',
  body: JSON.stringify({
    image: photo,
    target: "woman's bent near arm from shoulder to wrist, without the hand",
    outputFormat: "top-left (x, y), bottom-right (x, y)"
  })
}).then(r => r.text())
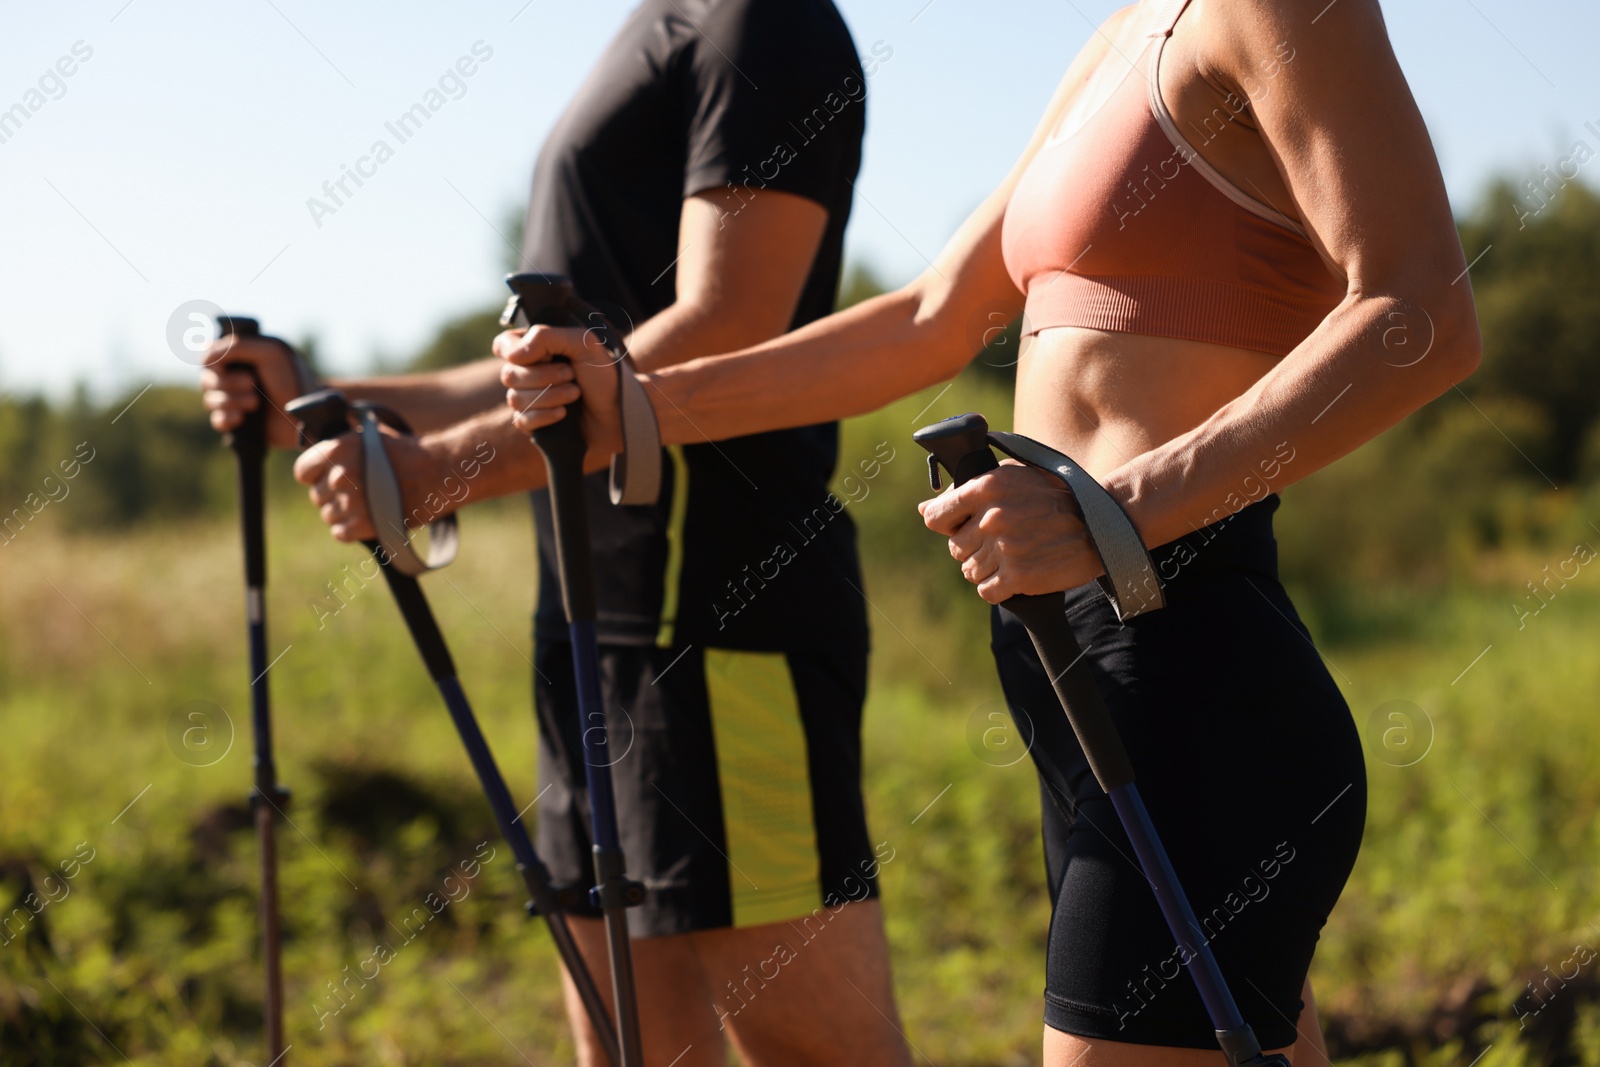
top-left (1106, 0), bottom-right (1480, 544)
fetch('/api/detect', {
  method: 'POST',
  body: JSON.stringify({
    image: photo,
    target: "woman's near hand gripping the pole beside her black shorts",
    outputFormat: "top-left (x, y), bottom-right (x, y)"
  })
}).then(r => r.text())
top-left (917, 461), bottom-right (1106, 603)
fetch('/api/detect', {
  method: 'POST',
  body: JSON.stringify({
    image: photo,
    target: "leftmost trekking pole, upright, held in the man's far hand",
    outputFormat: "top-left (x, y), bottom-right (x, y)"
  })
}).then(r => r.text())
top-left (218, 315), bottom-right (290, 1064)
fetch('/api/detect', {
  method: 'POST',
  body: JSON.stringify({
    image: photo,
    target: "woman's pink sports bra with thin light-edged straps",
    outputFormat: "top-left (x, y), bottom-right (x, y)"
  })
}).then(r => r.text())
top-left (1002, 0), bottom-right (1346, 355)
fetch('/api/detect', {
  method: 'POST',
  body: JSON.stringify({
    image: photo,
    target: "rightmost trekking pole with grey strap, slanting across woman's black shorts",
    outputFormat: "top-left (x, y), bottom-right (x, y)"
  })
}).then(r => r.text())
top-left (921, 413), bottom-right (1290, 1067)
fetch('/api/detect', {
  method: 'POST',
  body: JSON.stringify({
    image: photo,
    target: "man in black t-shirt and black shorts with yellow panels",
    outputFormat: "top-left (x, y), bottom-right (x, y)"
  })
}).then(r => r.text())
top-left (203, 0), bottom-right (910, 1067)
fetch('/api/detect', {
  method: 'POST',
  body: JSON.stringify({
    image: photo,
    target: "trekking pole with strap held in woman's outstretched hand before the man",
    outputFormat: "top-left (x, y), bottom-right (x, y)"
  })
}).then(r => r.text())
top-left (501, 274), bottom-right (661, 1067)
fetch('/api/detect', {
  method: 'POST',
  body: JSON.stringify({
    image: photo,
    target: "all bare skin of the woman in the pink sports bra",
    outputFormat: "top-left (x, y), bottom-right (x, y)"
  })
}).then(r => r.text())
top-left (494, 0), bottom-right (1480, 1067)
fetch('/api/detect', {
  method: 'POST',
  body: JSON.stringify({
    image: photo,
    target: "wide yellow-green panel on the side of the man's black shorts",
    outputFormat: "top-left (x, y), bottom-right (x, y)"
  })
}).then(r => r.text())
top-left (706, 648), bottom-right (822, 926)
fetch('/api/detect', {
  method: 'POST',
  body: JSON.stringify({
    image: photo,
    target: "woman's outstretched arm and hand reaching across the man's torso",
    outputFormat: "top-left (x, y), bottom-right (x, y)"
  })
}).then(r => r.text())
top-left (494, 8), bottom-right (1130, 451)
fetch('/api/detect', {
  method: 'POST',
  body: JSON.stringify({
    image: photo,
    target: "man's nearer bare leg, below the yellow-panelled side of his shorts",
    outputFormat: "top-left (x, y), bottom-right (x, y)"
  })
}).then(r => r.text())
top-left (690, 901), bottom-right (910, 1067)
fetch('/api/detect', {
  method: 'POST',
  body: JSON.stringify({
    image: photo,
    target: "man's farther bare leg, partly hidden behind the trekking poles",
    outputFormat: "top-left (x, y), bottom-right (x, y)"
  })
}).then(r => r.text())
top-left (562, 917), bottom-right (728, 1067)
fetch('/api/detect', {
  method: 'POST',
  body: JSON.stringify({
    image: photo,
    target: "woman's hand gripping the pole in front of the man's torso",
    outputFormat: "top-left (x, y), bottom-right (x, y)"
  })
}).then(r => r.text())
top-left (494, 326), bottom-right (622, 454)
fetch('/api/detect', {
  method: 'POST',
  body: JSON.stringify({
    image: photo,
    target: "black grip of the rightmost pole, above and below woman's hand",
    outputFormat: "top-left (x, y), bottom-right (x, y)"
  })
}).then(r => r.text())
top-left (912, 413), bottom-right (1133, 793)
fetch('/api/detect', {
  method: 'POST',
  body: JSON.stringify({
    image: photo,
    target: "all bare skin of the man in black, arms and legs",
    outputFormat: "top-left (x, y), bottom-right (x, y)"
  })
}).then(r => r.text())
top-left (202, 190), bottom-right (910, 1067)
